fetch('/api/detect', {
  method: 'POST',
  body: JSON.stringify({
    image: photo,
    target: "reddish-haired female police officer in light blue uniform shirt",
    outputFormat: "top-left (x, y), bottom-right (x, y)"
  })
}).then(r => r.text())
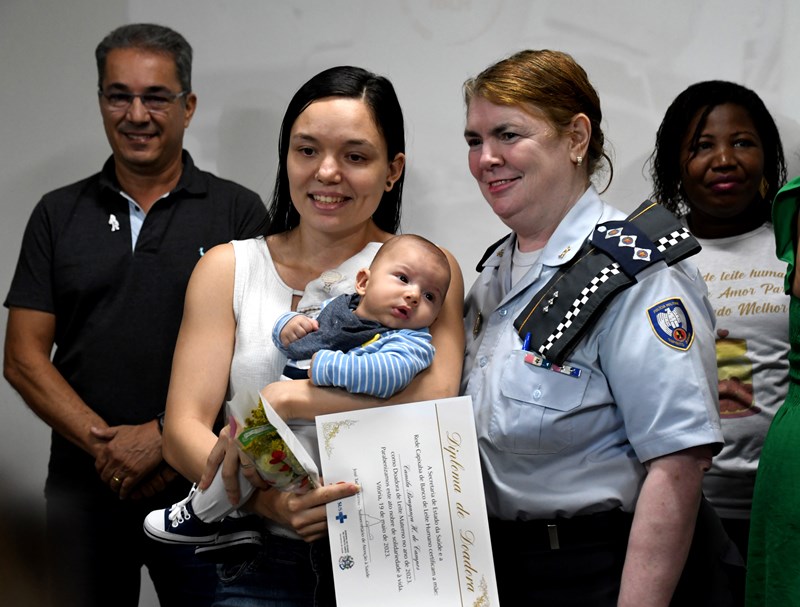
top-left (462, 51), bottom-right (722, 606)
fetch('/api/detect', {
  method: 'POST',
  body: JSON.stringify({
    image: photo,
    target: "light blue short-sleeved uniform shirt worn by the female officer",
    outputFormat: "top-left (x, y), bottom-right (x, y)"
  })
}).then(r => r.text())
top-left (462, 187), bottom-right (722, 520)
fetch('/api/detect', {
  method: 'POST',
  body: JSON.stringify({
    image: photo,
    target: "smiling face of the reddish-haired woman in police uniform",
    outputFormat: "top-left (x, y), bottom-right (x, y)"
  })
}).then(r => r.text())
top-left (464, 97), bottom-right (588, 246)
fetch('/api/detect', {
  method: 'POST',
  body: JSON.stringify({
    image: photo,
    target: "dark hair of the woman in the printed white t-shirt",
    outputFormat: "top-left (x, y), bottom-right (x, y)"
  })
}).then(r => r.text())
top-left (649, 80), bottom-right (786, 219)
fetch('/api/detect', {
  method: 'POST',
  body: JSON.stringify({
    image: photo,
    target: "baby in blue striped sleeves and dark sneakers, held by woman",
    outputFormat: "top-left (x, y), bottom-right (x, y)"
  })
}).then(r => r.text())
top-left (144, 234), bottom-right (450, 556)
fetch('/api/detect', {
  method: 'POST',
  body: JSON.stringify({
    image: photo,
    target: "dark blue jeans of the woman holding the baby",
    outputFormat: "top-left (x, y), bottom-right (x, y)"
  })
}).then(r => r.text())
top-left (214, 533), bottom-right (336, 607)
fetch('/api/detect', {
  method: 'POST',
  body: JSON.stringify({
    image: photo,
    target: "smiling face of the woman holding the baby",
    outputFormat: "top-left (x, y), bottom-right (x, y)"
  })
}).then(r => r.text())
top-left (286, 97), bottom-right (405, 240)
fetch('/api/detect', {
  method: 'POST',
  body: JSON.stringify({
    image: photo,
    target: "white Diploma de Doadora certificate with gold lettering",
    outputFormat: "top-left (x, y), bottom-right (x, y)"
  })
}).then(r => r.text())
top-left (316, 396), bottom-right (499, 607)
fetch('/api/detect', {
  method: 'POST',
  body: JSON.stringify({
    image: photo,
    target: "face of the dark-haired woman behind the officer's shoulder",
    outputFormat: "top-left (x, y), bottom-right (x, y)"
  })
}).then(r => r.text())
top-left (680, 103), bottom-right (764, 235)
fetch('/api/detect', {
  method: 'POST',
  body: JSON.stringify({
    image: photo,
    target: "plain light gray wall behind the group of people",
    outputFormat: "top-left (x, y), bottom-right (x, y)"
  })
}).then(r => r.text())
top-left (0, 0), bottom-right (800, 606)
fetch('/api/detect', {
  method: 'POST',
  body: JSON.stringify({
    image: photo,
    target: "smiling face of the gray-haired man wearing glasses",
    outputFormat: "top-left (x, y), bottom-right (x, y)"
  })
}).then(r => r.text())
top-left (100, 48), bottom-right (197, 175)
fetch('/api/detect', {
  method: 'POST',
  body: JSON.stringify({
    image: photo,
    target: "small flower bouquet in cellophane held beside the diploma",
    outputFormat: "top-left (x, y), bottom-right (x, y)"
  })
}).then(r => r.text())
top-left (227, 391), bottom-right (320, 493)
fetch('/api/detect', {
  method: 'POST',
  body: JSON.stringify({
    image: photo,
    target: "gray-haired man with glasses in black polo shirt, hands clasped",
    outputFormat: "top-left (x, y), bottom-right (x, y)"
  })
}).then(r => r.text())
top-left (4, 24), bottom-right (266, 607)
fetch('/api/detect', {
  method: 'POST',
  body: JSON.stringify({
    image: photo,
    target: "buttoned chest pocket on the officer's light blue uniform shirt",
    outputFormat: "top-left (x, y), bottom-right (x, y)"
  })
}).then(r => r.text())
top-left (490, 350), bottom-right (590, 455)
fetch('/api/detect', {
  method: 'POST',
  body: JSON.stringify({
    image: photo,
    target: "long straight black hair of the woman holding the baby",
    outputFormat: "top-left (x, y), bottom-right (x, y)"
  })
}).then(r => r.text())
top-left (267, 66), bottom-right (406, 235)
